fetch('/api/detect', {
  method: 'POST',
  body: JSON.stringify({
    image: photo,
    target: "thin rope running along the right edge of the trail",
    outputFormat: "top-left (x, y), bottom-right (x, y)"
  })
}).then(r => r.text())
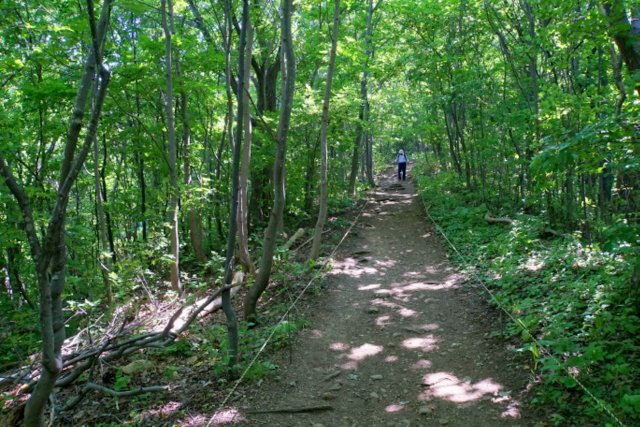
top-left (420, 195), bottom-right (626, 427)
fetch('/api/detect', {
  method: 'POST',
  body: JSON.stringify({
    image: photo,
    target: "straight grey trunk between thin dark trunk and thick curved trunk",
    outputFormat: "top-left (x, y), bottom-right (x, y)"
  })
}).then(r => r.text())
top-left (238, 19), bottom-right (256, 276)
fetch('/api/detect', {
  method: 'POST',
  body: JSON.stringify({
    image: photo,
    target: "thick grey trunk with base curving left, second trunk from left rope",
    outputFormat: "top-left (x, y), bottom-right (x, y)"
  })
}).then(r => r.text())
top-left (244, 0), bottom-right (295, 321)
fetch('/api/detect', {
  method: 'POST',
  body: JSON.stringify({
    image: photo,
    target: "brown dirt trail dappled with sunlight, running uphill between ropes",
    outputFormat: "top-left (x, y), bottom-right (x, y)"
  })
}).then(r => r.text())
top-left (224, 168), bottom-right (533, 427)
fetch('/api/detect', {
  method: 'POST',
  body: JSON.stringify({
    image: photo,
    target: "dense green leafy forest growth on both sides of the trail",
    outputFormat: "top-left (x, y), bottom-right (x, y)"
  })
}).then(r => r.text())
top-left (0, 0), bottom-right (640, 423)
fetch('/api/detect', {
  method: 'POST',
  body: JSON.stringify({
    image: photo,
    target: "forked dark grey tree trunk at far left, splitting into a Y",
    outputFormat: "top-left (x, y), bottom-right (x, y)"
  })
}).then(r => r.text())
top-left (0, 0), bottom-right (111, 426)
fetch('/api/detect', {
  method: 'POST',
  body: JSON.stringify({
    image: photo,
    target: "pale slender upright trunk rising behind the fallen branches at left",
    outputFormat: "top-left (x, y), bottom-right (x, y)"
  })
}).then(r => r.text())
top-left (162, 0), bottom-right (182, 293)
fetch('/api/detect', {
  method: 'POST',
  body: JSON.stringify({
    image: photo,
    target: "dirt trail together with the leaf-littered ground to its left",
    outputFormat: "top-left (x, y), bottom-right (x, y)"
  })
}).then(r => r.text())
top-left (0, 169), bottom-right (546, 427)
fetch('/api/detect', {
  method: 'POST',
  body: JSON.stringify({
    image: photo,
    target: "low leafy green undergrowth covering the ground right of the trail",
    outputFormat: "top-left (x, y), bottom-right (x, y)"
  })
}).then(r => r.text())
top-left (418, 173), bottom-right (640, 425)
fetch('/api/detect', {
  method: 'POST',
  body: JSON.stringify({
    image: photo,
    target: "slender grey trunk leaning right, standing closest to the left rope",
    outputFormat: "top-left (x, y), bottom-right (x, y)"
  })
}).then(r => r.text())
top-left (309, 0), bottom-right (340, 260)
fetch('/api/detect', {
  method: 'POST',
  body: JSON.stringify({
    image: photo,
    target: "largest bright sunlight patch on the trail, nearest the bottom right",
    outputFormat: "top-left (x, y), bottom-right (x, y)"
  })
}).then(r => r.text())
top-left (419, 372), bottom-right (502, 403)
